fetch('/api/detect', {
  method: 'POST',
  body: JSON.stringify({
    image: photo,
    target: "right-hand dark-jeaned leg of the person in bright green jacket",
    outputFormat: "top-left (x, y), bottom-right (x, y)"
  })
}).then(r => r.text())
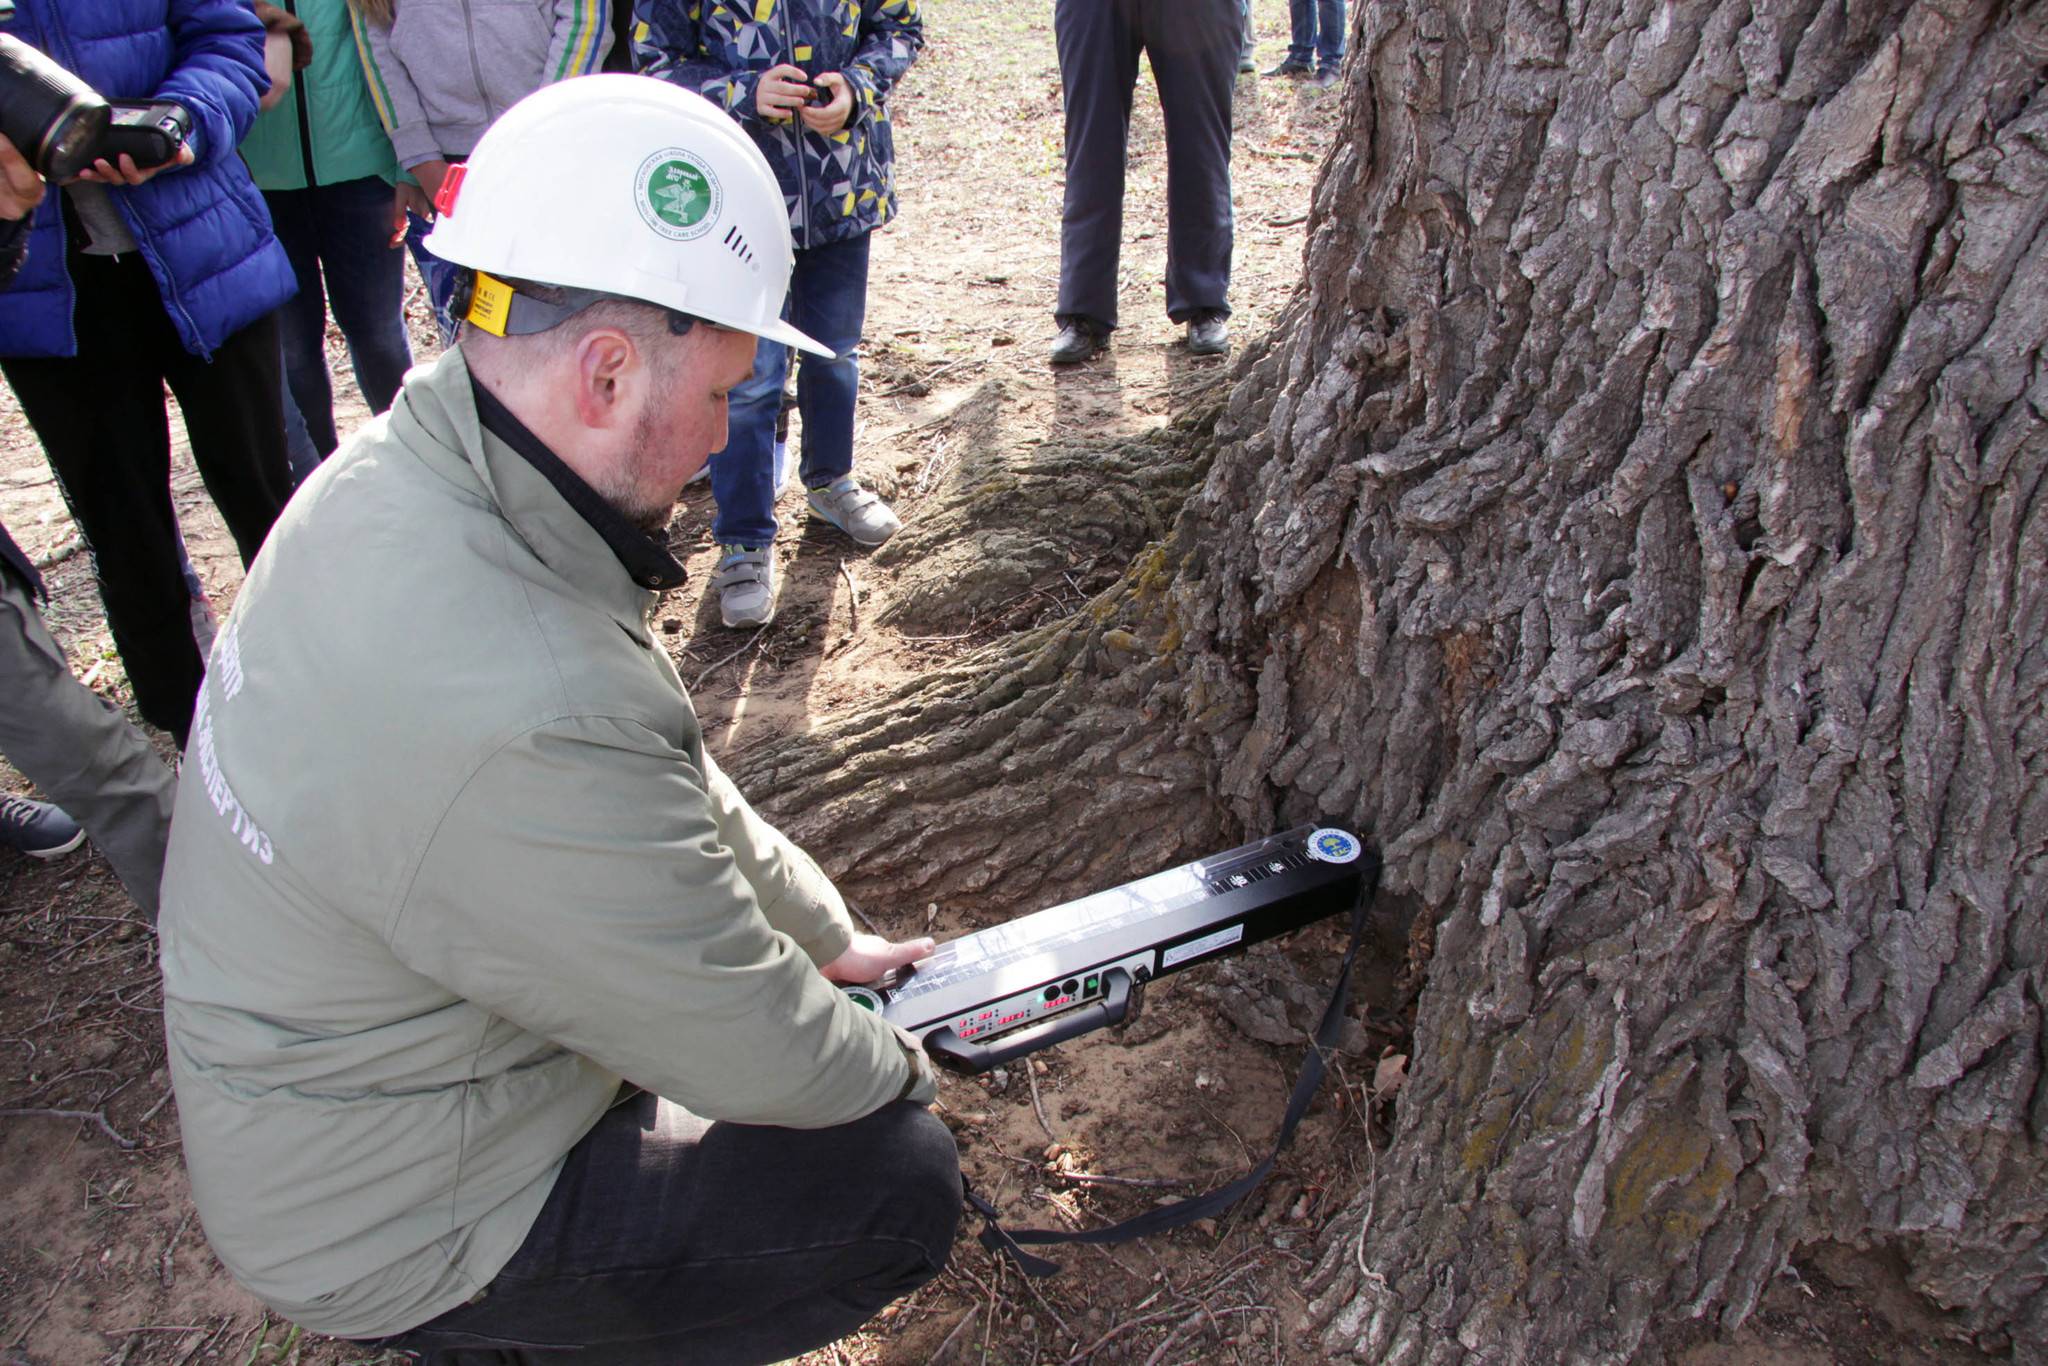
top-left (317, 176), bottom-right (412, 412)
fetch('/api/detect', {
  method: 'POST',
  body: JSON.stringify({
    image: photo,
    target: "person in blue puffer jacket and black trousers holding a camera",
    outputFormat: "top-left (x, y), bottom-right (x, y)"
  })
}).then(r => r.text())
top-left (0, 0), bottom-right (295, 748)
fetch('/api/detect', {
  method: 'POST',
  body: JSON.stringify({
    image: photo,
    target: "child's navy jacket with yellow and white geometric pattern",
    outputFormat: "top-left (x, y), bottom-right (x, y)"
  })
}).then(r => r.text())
top-left (633, 0), bottom-right (924, 248)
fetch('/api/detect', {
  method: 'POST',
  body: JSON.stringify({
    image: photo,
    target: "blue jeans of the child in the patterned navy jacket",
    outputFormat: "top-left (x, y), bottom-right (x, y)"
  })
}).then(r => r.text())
top-left (711, 233), bottom-right (868, 545)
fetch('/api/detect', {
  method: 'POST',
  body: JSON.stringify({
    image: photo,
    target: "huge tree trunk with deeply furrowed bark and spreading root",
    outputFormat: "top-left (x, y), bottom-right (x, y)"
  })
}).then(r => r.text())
top-left (741, 0), bottom-right (2048, 1362)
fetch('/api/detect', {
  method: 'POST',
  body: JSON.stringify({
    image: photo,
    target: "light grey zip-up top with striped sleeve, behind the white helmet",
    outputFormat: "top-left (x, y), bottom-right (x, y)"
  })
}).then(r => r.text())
top-left (360, 0), bottom-right (612, 170)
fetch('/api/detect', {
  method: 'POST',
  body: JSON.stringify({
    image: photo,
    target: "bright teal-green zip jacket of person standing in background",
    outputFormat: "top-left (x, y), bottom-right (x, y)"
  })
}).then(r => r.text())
top-left (242, 0), bottom-right (397, 190)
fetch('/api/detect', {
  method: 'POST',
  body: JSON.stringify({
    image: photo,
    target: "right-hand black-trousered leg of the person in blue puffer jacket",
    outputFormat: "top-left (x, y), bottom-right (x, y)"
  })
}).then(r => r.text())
top-left (164, 313), bottom-right (291, 567)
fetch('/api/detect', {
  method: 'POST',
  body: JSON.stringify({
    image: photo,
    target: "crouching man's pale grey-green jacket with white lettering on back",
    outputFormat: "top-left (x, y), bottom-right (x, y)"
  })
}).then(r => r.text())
top-left (160, 350), bottom-right (932, 1337)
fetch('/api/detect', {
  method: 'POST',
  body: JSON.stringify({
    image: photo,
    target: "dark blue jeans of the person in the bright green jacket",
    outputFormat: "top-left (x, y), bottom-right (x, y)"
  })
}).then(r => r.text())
top-left (264, 176), bottom-right (412, 481)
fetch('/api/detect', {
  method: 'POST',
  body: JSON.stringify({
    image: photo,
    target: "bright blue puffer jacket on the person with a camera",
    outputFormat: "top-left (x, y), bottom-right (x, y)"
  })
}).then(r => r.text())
top-left (0, 0), bottom-right (297, 358)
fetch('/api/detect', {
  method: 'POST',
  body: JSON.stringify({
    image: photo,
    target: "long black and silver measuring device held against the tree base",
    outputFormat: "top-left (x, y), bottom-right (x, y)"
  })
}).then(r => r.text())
top-left (846, 825), bottom-right (1378, 1073)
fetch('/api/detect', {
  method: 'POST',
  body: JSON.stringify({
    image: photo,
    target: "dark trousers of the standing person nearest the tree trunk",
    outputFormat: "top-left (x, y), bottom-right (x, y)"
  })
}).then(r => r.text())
top-left (1053, 0), bottom-right (1243, 328)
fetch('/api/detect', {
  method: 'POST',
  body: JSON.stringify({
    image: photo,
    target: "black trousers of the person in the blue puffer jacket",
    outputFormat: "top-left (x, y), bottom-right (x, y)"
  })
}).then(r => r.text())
top-left (0, 242), bottom-right (291, 748)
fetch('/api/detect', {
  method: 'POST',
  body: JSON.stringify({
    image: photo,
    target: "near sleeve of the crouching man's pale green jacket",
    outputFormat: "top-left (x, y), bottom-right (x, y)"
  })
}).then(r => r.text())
top-left (389, 719), bottom-right (932, 1128)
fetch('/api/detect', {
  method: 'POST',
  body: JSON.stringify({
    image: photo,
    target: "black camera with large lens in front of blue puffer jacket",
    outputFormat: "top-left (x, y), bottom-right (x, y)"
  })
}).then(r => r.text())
top-left (0, 0), bottom-right (193, 182)
